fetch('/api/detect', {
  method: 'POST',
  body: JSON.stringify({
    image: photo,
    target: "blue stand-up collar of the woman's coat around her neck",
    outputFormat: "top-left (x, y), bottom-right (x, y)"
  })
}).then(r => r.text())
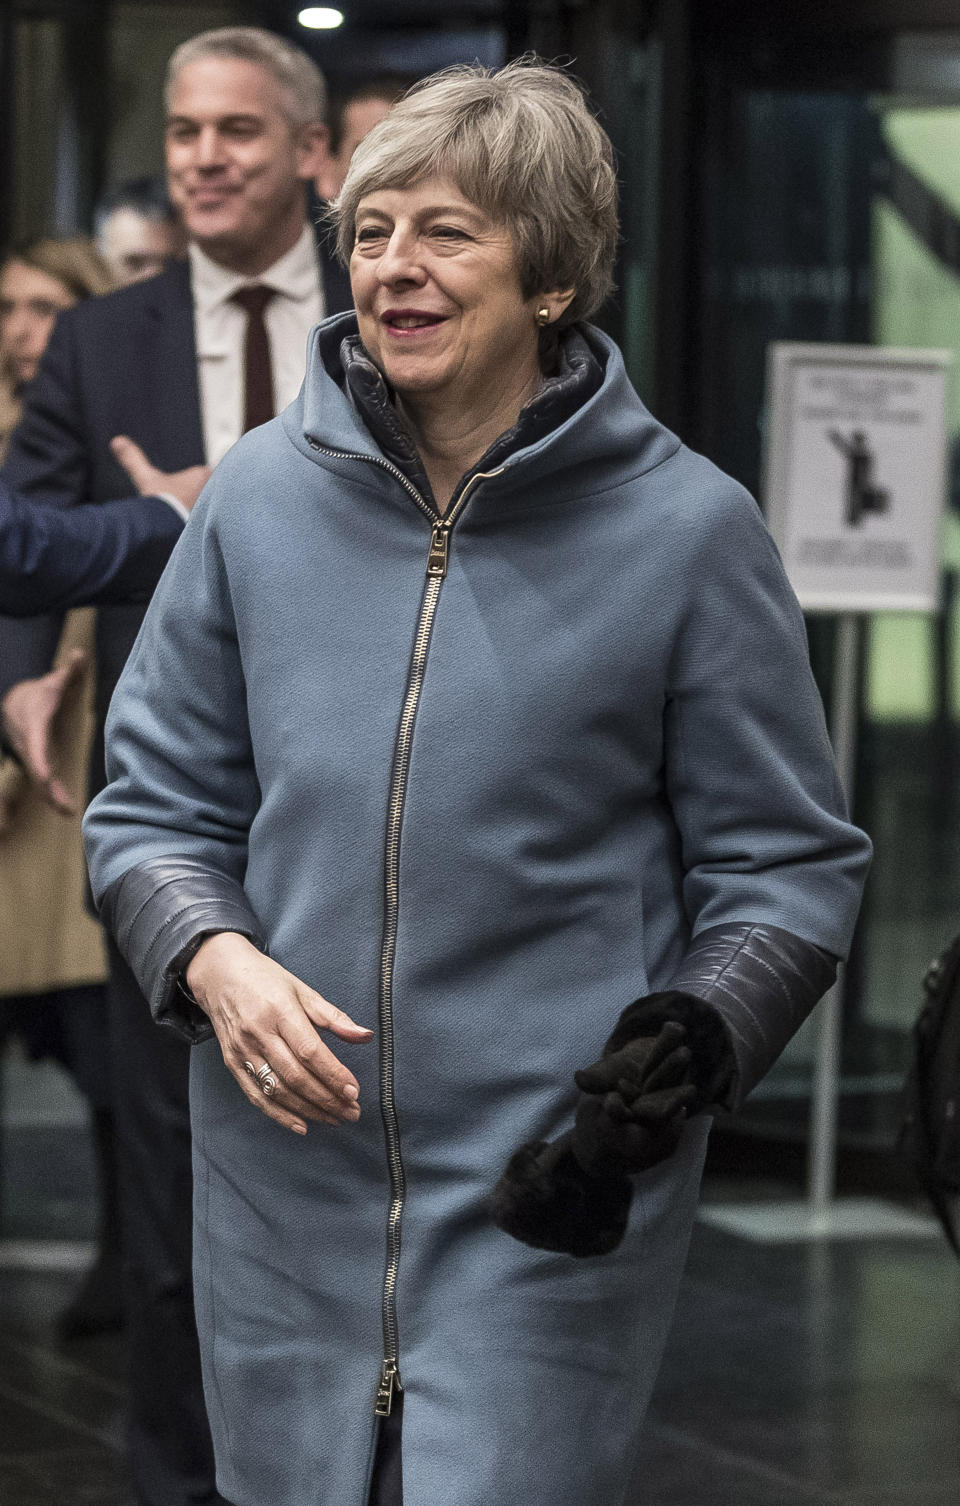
top-left (282, 313), bottom-right (680, 509)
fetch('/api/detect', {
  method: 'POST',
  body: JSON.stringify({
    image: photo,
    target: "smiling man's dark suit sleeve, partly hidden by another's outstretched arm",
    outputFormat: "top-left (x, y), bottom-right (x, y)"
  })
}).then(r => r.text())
top-left (0, 310), bottom-right (140, 696)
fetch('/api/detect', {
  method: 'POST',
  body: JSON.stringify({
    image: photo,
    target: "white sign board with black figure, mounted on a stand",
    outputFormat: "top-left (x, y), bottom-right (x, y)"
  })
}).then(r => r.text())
top-left (764, 342), bottom-right (951, 611)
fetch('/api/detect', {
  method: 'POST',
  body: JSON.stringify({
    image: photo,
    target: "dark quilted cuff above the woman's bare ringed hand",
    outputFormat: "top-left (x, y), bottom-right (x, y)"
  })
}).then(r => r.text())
top-left (99, 857), bottom-right (267, 1042)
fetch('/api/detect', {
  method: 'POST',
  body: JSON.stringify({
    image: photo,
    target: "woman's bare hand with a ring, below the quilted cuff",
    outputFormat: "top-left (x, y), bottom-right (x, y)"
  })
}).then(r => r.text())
top-left (185, 931), bottom-right (374, 1134)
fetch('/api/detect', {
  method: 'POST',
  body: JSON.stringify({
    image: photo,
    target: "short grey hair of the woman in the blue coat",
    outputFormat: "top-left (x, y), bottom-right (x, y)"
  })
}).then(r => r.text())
top-left (330, 57), bottom-right (618, 325)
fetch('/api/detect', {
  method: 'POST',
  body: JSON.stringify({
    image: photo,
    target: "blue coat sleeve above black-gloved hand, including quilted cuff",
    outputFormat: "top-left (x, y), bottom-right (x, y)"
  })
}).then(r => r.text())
top-left (665, 482), bottom-right (871, 1092)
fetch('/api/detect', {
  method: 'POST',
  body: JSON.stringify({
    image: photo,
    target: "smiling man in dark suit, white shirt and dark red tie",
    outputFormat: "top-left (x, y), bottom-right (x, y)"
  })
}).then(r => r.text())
top-left (0, 27), bottom-right (350, 1506)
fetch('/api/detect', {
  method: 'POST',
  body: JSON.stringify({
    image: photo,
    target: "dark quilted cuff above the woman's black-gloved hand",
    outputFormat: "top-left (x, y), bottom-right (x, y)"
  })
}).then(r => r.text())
top-left (669, 923), bottom-right (838, 1108)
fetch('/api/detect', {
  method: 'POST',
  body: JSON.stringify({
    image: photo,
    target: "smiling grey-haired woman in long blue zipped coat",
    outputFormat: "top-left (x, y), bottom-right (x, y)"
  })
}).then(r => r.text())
top-left (86, 62), bottom-right (870, 1506)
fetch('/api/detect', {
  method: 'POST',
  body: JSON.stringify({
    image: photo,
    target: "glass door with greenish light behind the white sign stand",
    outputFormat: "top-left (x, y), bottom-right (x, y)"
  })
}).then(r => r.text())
top-left (689, 33), bottom-right (960, 1151)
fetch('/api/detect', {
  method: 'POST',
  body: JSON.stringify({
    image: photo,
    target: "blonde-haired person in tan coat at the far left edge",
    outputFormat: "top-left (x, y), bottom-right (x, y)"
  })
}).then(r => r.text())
top-left (0, 235), bottom-right (119, 1336)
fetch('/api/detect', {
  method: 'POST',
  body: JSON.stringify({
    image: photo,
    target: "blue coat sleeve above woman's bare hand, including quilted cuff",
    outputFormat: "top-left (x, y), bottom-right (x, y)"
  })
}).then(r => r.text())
top-left (83, 480), bottom-right (262, 1039)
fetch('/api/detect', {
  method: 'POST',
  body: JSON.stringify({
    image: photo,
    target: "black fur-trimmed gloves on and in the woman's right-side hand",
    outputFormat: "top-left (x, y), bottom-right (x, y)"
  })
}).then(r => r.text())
top-left (491, 1000), bottom-right (702, 1256)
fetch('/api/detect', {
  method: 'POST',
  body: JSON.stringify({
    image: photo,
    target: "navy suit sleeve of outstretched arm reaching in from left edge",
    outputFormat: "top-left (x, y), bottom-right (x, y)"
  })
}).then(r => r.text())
top-left (0, 482), bottom-right (182, 616)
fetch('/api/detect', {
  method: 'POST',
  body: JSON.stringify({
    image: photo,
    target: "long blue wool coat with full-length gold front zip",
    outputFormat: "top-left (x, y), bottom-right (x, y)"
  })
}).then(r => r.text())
top-left (86, 318), bottom-right (868, 1506)
